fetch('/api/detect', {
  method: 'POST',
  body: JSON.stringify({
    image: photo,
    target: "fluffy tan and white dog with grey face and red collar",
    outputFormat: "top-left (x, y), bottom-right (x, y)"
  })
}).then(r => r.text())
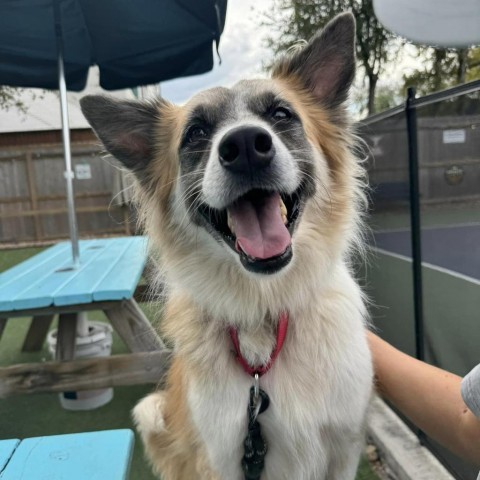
top-left (81, 13), bottom-right (372, 480)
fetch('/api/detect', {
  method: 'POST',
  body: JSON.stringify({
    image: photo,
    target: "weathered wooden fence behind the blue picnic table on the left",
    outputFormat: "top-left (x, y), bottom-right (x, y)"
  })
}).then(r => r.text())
top-left (0, 139), bottom-right (135, 246)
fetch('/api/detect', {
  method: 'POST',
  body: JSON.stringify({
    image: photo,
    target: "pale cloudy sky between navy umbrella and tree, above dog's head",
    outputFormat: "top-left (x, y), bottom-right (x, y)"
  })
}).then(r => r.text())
top-left (161, 0), bottom-right (272, 103)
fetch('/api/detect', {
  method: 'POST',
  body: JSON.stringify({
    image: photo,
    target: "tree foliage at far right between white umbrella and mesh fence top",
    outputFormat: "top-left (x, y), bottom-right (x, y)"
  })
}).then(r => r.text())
top-left (403, 47), bottom-right (480, 95)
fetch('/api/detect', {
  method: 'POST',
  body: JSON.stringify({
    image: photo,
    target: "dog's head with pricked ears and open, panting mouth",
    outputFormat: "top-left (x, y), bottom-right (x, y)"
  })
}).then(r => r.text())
top-left (81, 14), bottom-right (358, 312)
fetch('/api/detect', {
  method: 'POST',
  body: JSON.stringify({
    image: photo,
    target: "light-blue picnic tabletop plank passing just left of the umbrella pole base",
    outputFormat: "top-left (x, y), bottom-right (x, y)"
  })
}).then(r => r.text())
top-left (6, 240), bottom-right (109, 310)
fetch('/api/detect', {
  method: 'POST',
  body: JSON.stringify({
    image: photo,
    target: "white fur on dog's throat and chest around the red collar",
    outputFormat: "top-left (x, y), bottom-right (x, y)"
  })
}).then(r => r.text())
top-left (144, 192), bottom-right (372, 480)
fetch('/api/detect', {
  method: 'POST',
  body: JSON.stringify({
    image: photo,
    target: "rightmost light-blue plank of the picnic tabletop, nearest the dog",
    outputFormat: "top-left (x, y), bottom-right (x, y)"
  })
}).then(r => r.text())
top-left (93, 237), bottom-right (148, 302)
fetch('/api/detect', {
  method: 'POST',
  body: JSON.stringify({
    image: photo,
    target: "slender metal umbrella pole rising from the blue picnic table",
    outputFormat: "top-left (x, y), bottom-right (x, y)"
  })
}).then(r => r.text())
top-left (53, 0), bottom-right (80, 267)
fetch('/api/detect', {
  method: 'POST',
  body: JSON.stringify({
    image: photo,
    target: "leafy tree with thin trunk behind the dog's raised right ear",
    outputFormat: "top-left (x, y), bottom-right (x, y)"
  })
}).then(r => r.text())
top-left (263, 0), bottom-right (394, 114)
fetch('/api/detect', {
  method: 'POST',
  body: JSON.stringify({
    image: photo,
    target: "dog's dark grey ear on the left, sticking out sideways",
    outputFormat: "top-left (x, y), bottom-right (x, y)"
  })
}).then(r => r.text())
top-left (80, 95), bottom-right (159, 174)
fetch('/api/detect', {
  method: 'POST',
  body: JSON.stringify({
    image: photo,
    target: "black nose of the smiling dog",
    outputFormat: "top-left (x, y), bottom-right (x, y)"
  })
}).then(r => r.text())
top-left (218, 126), bottom-right (275, 173)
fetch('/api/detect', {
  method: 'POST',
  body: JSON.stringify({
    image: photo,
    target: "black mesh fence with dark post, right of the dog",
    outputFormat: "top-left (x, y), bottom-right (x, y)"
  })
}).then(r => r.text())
top-left (359, 82), bottom-right (480, 480)
